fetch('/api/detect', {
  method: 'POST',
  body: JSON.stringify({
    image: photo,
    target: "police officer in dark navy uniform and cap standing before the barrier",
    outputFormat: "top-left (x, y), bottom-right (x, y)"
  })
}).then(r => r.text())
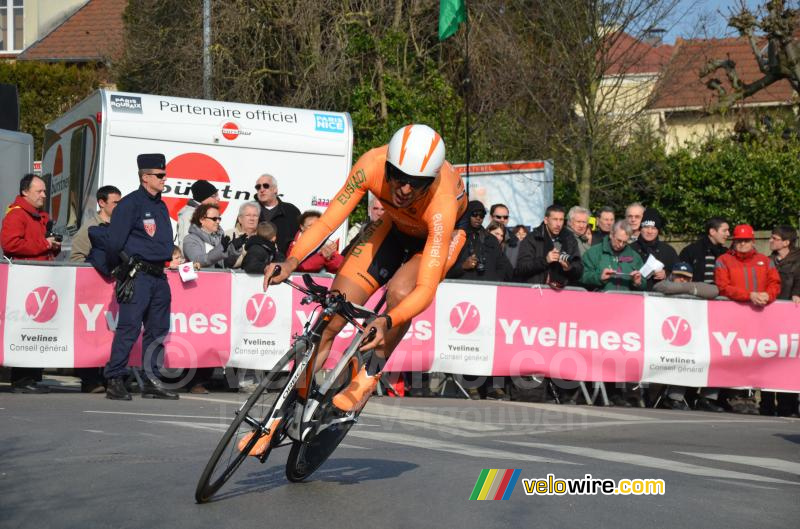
top-left (104, 154), bottom-right (178, 400)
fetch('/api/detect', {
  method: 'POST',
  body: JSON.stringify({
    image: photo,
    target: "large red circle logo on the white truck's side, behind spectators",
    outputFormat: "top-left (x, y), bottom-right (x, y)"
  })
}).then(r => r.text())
top-left (161, 152), bottom-right (231, 220)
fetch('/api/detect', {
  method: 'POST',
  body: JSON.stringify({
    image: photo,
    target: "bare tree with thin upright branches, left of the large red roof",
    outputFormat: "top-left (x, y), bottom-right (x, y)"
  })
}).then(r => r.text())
top-left (468, 0), bottom-right (678, 207)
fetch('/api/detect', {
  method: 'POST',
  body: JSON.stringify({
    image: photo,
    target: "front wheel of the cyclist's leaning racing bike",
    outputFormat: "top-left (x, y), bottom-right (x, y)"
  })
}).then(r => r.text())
top-left (194, 349), bottom-right (295, 503)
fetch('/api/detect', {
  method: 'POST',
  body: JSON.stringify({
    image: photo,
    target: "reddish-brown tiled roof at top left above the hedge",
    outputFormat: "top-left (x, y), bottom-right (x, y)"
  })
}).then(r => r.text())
top-left (17, 0), bottom-right (128, 62)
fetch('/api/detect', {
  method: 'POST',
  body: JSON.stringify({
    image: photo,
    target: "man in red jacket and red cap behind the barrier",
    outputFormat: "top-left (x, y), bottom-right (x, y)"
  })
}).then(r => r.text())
top-left (714, 224), bottom-right (781, 307)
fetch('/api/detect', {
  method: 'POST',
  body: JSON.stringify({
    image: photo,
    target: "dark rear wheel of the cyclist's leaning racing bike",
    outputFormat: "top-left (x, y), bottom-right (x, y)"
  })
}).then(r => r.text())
top-left (286, 360), bottom-right (361, 483)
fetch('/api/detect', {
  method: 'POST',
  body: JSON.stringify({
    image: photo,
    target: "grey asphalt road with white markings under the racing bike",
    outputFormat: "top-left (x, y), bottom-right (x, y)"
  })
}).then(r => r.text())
top-left (0, 380), bottom-right (800, 529)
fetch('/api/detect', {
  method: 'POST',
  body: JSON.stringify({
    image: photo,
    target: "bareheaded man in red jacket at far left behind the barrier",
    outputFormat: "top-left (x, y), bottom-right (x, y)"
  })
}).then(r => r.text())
top-left (0, 174), bottom-right (61, 393)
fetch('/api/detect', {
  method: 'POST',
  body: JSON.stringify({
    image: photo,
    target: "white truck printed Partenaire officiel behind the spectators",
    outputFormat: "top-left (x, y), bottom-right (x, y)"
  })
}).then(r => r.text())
top-left (42, 90), bottom-right (353, 245)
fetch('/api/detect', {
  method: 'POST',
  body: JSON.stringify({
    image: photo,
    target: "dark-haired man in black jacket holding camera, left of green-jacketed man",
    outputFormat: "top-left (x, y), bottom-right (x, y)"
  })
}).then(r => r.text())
top-left (514, 204), bottom-right (583, 288)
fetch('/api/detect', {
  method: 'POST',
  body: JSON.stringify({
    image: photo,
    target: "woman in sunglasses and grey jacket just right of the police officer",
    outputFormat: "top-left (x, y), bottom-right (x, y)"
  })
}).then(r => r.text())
top-left (183, 204), bottom-right (230, 268)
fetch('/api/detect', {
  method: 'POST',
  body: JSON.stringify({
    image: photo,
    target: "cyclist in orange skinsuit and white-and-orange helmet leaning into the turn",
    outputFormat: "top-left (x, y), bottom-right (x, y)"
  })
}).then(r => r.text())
top-left (264, 124), bottom-right (467, 412)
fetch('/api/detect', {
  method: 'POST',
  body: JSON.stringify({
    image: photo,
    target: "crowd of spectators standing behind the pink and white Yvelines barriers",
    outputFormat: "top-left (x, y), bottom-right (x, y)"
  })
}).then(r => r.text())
top-left (0, 170), bottom-right (800, 416)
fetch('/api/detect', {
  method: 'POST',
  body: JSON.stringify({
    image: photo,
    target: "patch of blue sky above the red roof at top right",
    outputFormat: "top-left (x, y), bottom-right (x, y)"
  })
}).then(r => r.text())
top-left (664, 0), bottom-right (772, 44)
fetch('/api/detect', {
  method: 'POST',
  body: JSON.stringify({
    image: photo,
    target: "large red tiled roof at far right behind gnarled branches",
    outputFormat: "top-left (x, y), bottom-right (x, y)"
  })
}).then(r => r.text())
top-left (650, 38), bottom-right (795, 109)
